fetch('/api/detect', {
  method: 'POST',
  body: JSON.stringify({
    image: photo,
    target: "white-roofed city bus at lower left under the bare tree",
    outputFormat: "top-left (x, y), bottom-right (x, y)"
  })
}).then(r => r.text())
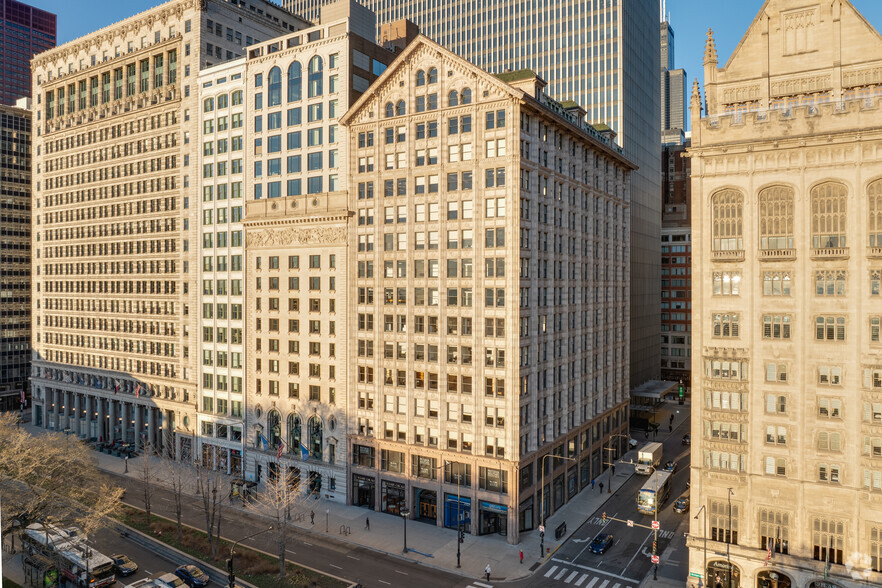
top-left (21, 523), bottom-right (116, 588)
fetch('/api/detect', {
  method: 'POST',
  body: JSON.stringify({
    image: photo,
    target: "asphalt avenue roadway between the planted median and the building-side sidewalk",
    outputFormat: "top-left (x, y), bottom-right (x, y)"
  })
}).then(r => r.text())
top-left (108, 474), bottom-right (474, 588)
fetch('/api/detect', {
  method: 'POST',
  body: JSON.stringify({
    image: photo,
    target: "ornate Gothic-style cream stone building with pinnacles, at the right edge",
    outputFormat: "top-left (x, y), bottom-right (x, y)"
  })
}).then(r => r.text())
top-left (688, 0), bottom-right (882, 588)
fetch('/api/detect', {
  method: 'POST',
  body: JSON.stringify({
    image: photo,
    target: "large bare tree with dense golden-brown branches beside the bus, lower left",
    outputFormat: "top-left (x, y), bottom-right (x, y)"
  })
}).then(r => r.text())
top-left (0, 413), bottom-right (123, 534)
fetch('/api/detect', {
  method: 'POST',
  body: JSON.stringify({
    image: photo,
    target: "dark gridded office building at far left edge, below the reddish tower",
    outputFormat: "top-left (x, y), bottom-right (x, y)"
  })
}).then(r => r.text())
top-left (0, 98), bottom-right (31, 410)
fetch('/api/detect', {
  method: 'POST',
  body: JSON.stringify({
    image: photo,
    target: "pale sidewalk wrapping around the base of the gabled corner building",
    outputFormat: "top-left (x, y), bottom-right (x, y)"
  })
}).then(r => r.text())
top-left (22, 403), bottom-right (688, 585)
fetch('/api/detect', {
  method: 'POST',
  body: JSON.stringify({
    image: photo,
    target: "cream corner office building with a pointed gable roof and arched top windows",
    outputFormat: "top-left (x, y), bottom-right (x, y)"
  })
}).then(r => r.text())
top-left (338, 36), bottom-right (632, 543)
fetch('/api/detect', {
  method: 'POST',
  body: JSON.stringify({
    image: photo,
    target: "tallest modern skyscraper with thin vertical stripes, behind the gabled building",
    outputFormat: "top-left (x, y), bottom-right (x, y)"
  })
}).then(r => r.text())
top-left (282, 0), bottom-right (661, 387)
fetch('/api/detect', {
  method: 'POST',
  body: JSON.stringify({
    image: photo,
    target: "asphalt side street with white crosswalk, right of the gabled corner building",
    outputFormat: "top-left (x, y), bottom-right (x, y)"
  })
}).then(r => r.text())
top-left (510, 421), bottom-right (690, 588)
